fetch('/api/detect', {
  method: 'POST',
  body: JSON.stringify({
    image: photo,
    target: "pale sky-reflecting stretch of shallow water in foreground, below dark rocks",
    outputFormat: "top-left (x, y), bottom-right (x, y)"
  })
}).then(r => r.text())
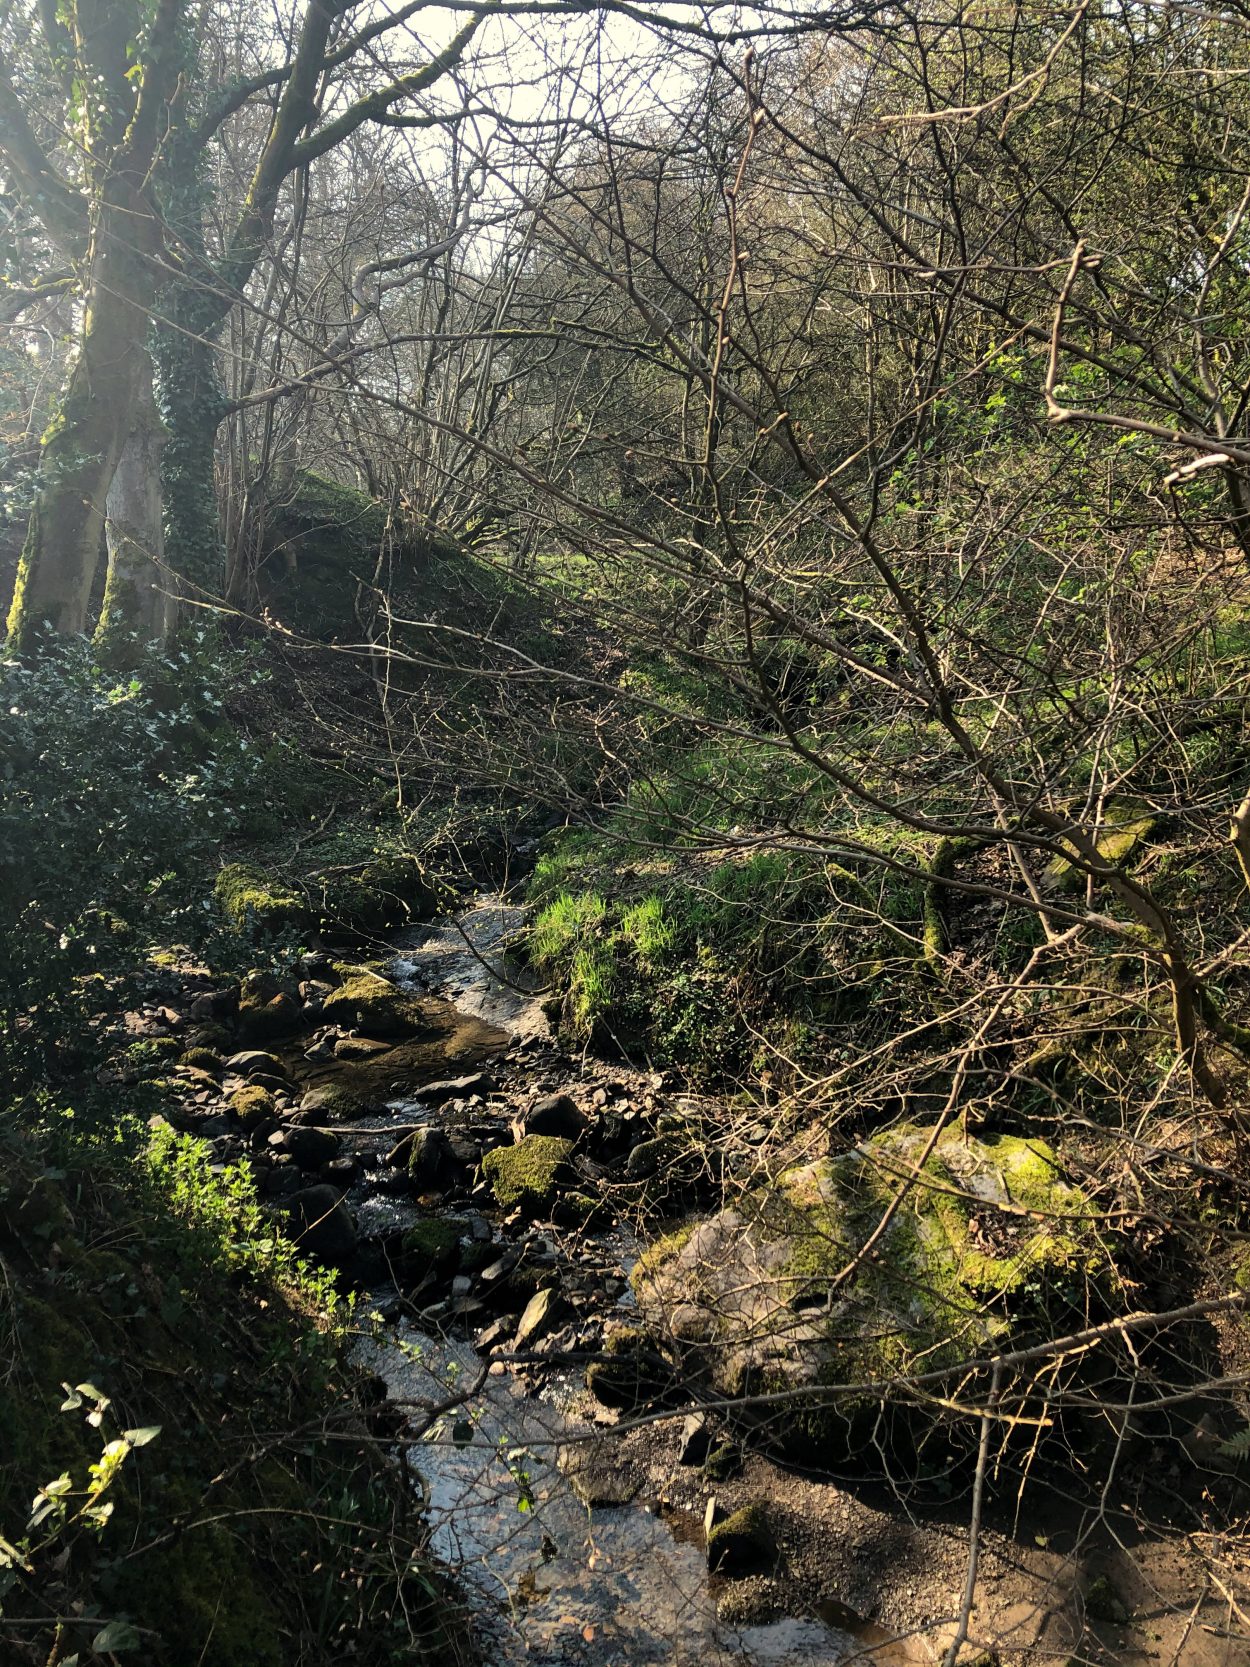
top-left (368, 1332), bottom-right (905, 1667)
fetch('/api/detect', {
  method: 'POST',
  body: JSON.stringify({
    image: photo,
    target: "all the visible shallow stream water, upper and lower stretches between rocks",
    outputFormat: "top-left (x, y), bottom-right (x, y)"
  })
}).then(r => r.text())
top-left (337, 897), bottom-right (913, 1667)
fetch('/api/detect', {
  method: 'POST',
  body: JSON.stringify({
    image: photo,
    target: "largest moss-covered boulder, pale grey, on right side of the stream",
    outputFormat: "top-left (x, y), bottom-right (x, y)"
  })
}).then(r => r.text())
top-left (633, 1124), bottom-right (1115, 1459)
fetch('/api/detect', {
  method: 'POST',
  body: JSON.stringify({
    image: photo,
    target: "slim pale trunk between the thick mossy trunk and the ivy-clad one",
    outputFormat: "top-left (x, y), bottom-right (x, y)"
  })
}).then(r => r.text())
top-left (97, 362), bottom-right (178, 658)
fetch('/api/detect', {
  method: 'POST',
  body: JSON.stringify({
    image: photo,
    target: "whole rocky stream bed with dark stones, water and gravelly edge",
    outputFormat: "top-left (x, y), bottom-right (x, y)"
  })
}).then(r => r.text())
top-left (115, 897), bottom-right (1240, 1667)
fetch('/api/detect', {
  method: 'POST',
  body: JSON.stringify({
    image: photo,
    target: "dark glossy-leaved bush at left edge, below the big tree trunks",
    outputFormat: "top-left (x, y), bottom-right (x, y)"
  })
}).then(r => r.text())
top-left (0, 643), bottom-right (265, 1085)
